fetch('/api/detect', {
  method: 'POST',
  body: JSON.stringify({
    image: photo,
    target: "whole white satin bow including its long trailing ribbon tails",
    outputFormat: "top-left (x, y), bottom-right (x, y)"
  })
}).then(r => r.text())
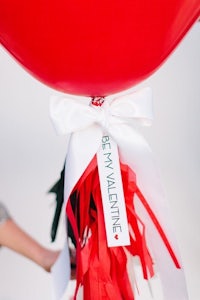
top-left (50, 88), bottom-right (188, 300)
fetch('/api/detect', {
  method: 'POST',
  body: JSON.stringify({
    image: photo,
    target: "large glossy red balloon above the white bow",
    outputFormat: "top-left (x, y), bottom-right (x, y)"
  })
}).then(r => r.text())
top-left (0, 0), bottom-right (200, 96)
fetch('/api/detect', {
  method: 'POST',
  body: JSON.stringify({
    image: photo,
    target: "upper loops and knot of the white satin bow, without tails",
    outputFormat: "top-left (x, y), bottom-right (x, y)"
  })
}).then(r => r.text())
top-left (50, 88), bottom-right (153, 135)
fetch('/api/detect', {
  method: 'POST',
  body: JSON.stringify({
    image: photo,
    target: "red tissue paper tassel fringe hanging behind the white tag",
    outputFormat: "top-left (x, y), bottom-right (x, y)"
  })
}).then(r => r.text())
top-left (67, 156), bottom-right (180, 300)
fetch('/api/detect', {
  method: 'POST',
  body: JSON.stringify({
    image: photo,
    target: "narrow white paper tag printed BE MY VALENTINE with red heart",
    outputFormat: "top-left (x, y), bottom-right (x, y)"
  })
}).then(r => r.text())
top-left (97, 135), bottom-right (130, 247)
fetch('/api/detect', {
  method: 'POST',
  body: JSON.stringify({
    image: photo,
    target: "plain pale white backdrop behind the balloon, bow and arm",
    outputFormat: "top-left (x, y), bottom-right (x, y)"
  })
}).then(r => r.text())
top-left (0, 23), bottom-right (200, 300)
